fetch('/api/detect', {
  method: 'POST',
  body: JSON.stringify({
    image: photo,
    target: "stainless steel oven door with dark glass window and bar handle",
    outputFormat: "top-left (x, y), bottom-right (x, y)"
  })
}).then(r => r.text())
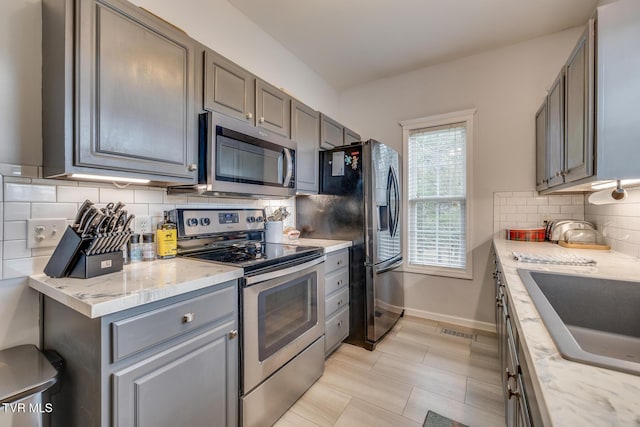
top-left (242, 257), bottom-right (324, 395)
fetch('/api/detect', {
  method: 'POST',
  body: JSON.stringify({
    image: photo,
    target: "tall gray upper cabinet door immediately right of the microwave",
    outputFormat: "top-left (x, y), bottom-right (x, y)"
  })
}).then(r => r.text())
top-left (291, 99), bottom-right (320, 193)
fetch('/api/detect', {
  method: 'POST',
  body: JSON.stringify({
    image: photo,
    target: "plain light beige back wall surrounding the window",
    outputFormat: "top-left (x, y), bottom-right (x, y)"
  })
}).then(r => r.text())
top-left (341, 28), bottom-right (582, 327)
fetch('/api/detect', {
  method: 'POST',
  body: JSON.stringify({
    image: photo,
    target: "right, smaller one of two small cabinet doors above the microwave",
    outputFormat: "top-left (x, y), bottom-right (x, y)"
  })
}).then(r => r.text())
top-left (256, 79), bottom-right (291, 138)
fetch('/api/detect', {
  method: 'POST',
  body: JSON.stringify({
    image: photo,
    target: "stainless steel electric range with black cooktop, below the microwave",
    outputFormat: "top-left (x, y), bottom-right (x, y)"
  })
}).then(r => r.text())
top-left (170, 209), bottom-right (324, 427)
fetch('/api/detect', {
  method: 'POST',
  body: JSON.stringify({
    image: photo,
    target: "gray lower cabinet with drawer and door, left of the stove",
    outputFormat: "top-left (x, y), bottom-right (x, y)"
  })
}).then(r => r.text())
top-left (43, 281), bottom-right (239, 427)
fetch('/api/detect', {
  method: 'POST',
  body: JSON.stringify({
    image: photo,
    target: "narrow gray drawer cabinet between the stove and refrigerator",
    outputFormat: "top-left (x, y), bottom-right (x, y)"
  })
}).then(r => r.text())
top-left (324, 249), bottom-right (349, 356)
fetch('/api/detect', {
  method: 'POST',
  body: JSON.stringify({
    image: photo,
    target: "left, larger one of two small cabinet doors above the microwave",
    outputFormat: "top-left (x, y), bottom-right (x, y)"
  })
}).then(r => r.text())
top-left (204, 49), bottom-right (256, 124)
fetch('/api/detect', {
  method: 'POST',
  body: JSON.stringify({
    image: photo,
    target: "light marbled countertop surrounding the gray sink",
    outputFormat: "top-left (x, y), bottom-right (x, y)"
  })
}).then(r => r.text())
top-left (494, 239), bottom-right (640, 426)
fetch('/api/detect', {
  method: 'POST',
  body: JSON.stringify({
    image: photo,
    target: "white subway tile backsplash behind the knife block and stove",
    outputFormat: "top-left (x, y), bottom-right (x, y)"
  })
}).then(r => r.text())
top-left (0, 176), bottom-right (295, 283)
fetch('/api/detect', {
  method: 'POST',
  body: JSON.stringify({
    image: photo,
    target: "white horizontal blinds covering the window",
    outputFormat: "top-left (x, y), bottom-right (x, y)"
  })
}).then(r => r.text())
top-left (407, 122), bottom-right (467, 270)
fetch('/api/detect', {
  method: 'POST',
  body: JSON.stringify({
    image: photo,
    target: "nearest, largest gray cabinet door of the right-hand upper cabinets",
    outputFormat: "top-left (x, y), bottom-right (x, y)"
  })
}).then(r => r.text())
top-left (564, 20), bottom-right (594, 182)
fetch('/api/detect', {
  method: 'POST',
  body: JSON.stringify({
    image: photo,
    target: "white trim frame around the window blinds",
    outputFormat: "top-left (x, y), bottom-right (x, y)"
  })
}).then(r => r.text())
top-left (400, 108), bottom-right (476, 280)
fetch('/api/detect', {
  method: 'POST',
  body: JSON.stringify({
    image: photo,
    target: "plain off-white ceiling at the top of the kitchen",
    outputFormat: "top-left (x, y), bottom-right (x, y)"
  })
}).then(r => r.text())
top-left (228, 0), bottom-right (602, 90)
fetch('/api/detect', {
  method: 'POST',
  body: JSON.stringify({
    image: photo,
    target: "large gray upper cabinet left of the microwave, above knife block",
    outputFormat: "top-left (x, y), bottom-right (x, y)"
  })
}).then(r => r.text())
top-left (43, 0), bottom-right (198, 183)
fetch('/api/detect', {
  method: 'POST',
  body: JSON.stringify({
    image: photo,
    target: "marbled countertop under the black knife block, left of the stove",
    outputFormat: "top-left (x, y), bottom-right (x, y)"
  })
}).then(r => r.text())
top-left (29, 258), bottom-right (243, 318)
